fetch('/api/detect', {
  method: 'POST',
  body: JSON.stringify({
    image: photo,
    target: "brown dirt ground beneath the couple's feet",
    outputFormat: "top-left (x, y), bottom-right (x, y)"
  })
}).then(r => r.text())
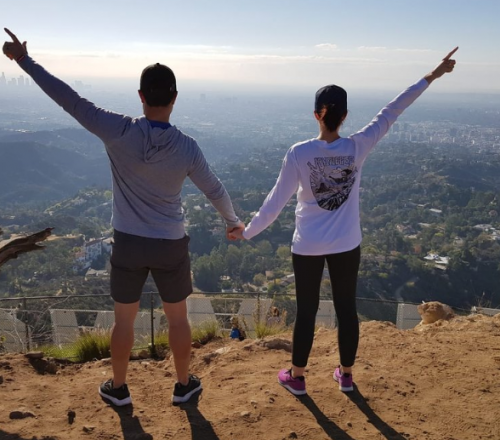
top-left (0, 315), bottom-right (500, 440)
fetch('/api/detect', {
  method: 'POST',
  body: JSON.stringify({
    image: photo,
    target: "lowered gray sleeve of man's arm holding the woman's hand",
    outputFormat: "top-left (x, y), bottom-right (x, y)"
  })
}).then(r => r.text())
top-left (188, 141), bottom-right (240, 228)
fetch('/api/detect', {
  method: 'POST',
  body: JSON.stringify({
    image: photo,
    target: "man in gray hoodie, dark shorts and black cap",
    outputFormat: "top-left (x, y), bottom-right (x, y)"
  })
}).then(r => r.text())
top-left (3, 29), bottom-right (244, 406)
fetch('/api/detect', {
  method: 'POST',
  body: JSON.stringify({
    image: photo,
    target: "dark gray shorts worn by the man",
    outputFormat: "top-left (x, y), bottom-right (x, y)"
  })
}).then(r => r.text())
top-left (111, 230), bottom-right (193, 304)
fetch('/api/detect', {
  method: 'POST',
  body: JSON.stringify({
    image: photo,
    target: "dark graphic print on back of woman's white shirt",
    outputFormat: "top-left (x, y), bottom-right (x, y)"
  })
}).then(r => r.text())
top-left (307, 156), bottom-right (358, 211)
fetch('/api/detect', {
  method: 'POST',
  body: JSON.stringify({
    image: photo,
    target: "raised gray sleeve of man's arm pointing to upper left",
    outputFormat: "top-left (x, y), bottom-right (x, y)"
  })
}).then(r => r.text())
top-left (19, 56), bottom-right (132, 143)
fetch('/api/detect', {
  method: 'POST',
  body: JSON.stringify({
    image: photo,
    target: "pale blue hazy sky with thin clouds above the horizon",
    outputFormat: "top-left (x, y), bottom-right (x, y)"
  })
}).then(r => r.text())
top-left (0, 0), bottom-right (500, 93)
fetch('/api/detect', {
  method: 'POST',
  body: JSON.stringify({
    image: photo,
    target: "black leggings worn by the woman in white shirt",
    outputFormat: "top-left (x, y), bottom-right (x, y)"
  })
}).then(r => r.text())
top-left (292, 246), bottom-right (361, 368)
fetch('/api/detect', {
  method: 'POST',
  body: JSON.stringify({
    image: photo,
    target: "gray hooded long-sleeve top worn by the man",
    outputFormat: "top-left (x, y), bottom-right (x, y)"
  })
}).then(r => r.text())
top-left (19, 56), bottom-right (239, 239)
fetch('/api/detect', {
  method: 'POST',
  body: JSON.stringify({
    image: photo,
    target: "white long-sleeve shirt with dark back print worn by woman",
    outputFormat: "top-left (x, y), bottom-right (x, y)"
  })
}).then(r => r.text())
top-left (243, 79), bottom-right (429, 255)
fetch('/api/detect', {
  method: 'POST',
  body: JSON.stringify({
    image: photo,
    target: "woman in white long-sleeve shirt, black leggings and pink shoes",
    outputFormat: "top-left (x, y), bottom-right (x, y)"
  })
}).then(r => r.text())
top-left (230, 47), bottom-right (458, 395)
